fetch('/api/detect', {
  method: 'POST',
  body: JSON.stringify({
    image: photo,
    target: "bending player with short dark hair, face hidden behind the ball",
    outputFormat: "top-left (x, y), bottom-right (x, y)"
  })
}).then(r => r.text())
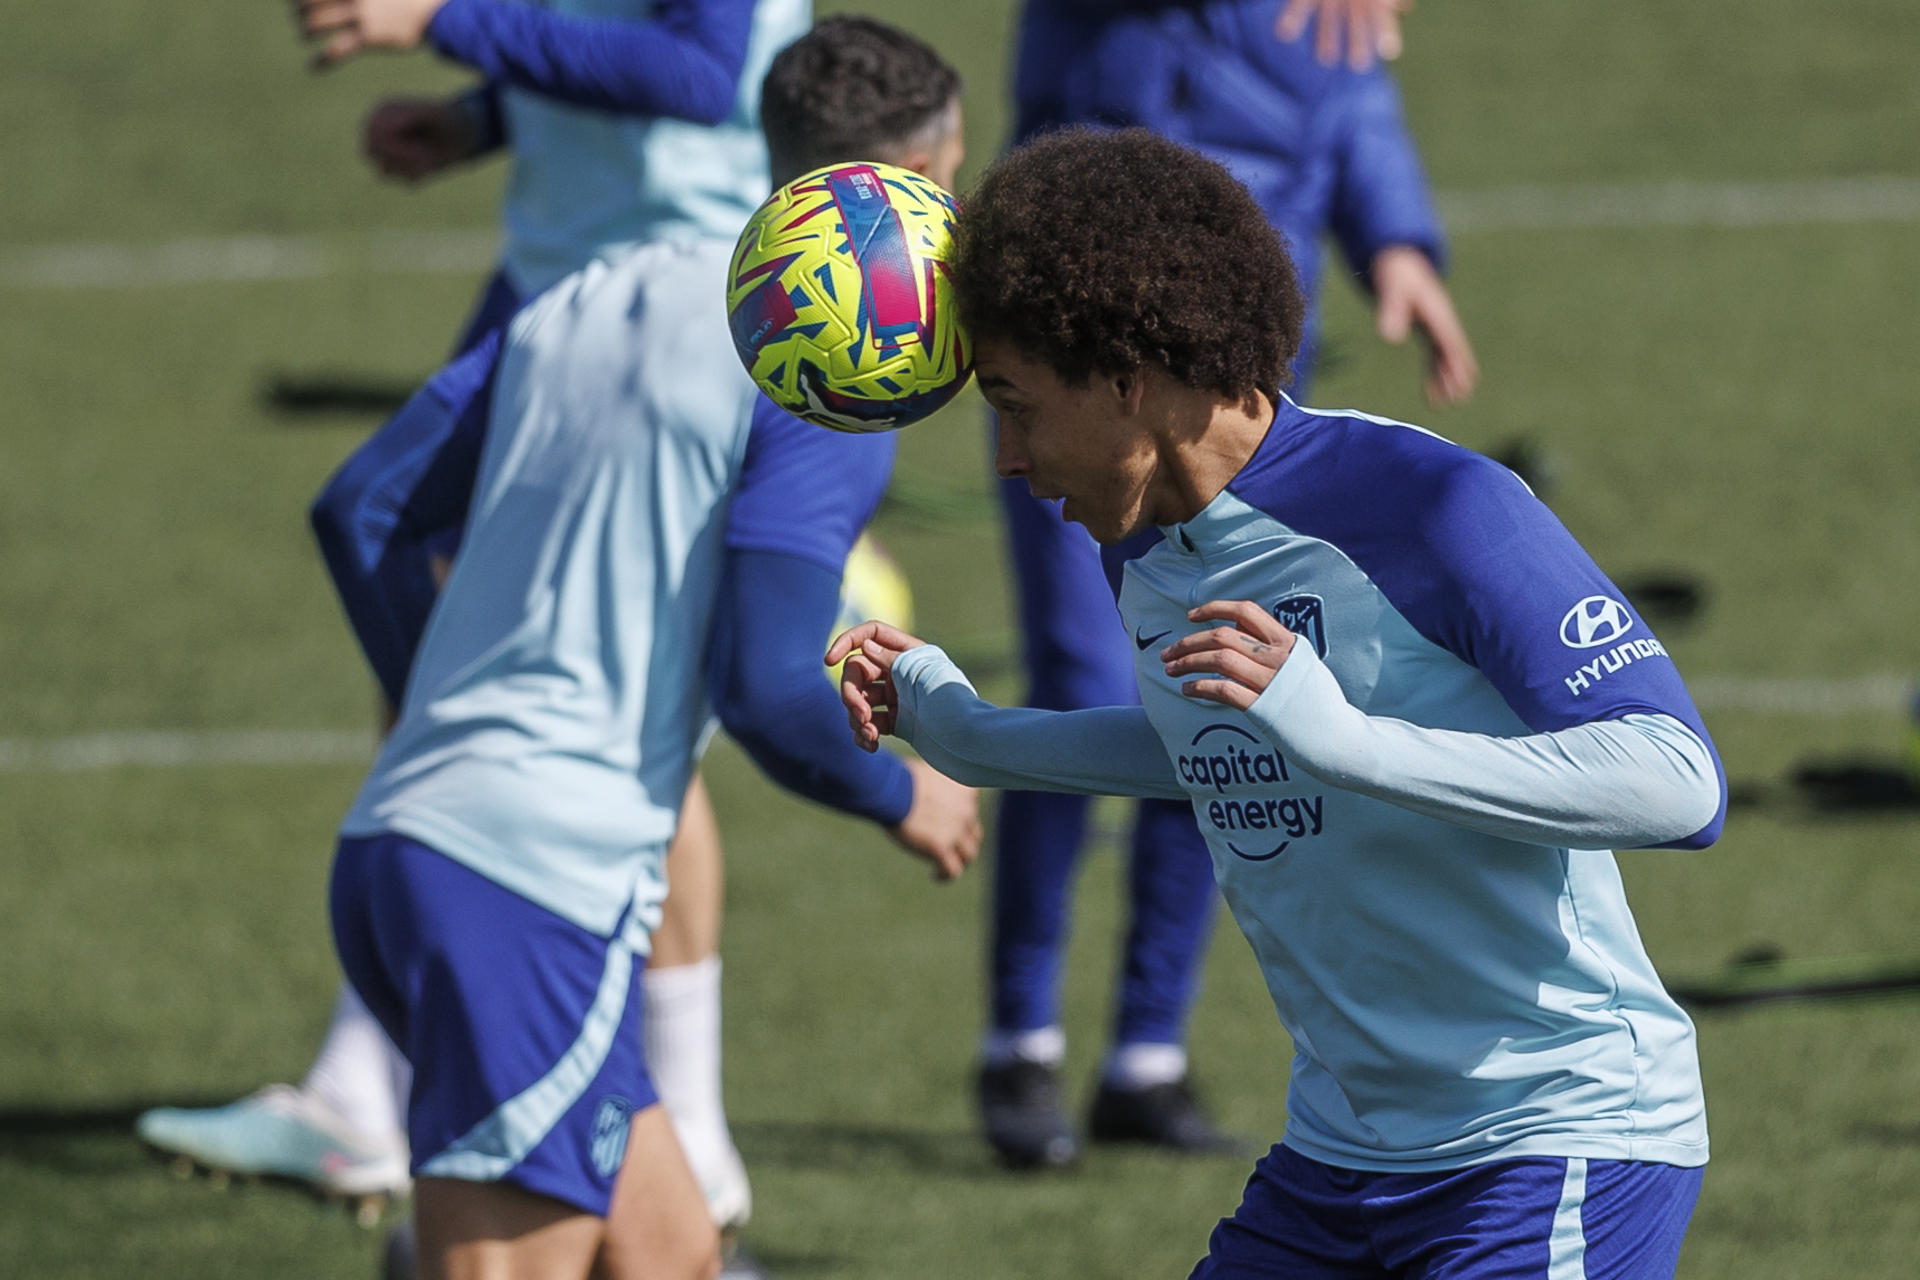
top-left (314, 21), bottom-right (979, 1274)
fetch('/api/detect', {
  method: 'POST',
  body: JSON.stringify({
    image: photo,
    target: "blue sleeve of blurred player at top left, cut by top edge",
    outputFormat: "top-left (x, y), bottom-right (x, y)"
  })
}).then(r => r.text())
top-left (426, 0), bottom-right (755, 125)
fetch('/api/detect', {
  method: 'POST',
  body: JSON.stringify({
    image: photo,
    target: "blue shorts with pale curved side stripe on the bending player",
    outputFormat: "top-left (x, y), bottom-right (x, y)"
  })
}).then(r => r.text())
top-left (330, 835), bottom-right (659, 1217)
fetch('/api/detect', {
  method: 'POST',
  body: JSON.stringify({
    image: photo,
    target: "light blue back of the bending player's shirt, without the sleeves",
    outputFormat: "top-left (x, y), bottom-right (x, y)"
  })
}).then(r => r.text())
top-left (342, 240), bottom-right (758, 952)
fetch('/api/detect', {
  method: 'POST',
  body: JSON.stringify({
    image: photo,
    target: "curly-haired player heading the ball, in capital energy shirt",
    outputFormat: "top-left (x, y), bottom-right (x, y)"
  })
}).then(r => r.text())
top-left (828, 130), bottom-right (1726, 1278)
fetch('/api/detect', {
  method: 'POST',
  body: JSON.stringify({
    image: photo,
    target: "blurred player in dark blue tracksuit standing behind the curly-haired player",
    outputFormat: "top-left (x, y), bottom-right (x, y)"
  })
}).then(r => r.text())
top-left (979, 0), bottom-right (1478, 1165)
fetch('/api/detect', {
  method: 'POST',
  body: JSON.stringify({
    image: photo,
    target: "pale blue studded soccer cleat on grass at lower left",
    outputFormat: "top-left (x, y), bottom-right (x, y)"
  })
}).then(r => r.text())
top-left (134, 1084), bottom-right (411, 1226)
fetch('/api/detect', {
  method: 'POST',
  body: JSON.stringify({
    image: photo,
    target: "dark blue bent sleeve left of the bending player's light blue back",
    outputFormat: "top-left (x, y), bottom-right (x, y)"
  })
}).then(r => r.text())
top-left (309, 332), bottom-right (501, 706)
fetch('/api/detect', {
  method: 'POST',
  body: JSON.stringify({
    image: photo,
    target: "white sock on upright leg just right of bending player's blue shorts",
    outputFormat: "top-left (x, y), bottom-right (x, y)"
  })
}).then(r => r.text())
top-left (641, 956), bottom-right (751, 1226)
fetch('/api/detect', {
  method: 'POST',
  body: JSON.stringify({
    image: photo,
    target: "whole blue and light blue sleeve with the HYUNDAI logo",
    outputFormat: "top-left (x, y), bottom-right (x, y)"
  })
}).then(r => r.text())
top-left (1250, 445), bottom-right (1726, 848)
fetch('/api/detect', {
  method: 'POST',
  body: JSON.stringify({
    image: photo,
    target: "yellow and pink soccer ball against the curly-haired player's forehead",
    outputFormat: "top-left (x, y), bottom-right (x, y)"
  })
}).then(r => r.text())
top-left (726, 163), bottom-right (973, 432)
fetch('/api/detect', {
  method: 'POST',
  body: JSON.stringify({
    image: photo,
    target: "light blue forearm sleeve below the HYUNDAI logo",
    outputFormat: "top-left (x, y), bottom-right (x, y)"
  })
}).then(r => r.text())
top-left (1248, 645), bottom-right (1722, 848)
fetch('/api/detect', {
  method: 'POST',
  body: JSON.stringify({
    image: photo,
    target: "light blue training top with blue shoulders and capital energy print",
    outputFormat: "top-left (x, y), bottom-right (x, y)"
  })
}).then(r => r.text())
top-left (895, 399), bottom-right (1726, 1171)
